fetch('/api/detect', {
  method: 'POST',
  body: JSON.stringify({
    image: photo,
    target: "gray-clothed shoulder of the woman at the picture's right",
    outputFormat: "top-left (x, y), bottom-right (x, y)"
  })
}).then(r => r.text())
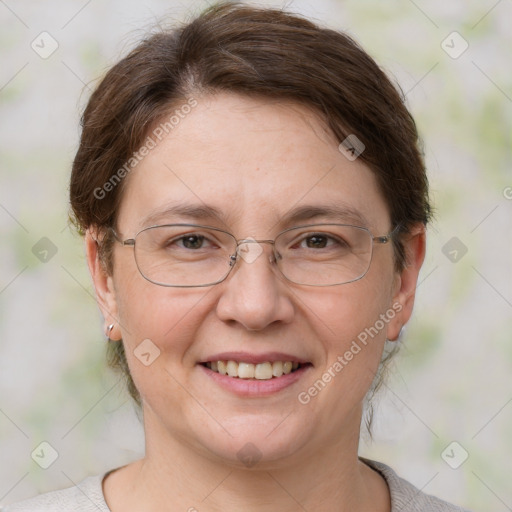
top-left (360, 458), bottom-right (468, 512)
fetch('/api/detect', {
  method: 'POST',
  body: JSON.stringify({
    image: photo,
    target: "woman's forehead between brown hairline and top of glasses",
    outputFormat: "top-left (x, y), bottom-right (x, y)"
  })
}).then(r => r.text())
top-left (118, 94), bottom-right (388, 236)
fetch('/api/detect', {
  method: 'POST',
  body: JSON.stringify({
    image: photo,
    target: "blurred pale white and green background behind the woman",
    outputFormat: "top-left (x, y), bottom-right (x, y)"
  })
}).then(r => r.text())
top-left (0, 0), bottom-right (512, 512)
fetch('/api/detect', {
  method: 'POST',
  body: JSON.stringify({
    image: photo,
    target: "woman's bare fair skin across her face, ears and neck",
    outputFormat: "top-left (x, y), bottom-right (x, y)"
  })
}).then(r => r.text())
top-left (86, 93), bottom-right (425, 512)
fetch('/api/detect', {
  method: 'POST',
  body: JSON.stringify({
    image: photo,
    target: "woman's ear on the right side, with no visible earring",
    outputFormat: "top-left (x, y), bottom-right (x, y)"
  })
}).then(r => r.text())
top-left (387, 223), bottom-right (426, 340)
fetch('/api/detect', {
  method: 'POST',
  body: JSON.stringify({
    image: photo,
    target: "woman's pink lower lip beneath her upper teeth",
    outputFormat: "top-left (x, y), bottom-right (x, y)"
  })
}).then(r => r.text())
top-left (197, 356), bottom-right (312, 398)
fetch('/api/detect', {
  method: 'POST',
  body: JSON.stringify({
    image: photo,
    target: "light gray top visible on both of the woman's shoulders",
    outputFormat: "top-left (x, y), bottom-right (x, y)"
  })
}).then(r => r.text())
top-left (0, 459), bottom-right (468, 512)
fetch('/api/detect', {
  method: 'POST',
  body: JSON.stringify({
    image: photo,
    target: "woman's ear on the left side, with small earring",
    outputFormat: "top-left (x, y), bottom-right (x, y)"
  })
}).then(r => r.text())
top-left (85, 228), bottom-right (121, 340)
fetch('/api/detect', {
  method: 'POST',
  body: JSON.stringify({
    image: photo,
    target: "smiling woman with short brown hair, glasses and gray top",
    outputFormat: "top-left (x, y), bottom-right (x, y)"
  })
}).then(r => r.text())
top-left (7, 4), bottom-right (472, 512)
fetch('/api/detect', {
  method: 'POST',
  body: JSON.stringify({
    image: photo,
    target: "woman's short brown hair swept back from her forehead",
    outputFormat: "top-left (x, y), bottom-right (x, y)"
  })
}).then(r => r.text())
top-left (70, 2), bottom-right (432, 404)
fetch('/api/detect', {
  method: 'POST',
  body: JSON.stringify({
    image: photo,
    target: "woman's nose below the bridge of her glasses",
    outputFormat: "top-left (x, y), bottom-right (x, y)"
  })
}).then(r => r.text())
top-left (217, 240), bottom-right (294, 331)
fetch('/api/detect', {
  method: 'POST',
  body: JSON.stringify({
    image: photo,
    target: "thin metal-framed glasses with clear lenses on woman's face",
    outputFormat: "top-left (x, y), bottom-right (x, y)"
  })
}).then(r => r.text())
top-left (110, 224), bottom-right (398, 288)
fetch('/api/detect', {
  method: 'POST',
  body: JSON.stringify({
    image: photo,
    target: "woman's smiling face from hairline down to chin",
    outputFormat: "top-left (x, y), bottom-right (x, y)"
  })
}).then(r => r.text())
top-left (89, 94), bottom-right (423, 465)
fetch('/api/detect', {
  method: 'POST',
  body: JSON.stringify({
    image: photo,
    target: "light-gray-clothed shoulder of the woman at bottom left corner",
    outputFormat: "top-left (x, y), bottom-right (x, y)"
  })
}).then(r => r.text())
top-left (0, 475), bottom-right (110, 512)
